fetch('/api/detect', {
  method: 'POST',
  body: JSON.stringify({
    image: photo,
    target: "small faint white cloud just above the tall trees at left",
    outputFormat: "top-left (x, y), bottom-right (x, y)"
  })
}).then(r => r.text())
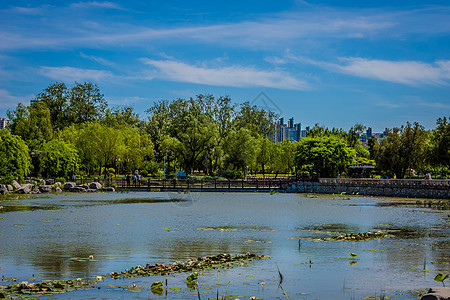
top-left (39, 67), bottom-right (114, 82)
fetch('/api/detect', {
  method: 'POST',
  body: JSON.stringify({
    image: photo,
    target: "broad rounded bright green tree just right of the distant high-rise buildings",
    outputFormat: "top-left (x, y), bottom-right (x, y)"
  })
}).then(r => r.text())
top-left (295, 136), bottom-right (356, 177)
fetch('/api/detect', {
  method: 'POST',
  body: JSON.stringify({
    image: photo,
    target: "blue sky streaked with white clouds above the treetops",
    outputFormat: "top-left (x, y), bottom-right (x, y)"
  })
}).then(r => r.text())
top-left (0, 0), bottom-right (450, 132)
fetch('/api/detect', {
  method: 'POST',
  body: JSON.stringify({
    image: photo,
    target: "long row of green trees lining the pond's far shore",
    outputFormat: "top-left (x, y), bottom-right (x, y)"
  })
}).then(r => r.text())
top-left (0, 83), bottom-right (450, 183)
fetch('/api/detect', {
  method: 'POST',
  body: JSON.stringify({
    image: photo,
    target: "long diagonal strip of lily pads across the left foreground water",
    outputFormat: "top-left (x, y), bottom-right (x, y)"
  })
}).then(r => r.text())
top-left (0, 252), bottom-right (270, 298)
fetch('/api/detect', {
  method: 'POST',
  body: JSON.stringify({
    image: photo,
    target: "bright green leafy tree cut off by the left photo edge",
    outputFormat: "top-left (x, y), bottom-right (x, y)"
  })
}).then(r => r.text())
top-left (0, 129), bottom-right (31, 181)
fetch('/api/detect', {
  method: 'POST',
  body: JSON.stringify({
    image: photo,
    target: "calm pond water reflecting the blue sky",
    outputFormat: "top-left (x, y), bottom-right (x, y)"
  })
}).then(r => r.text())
top-left (0, 192), bottom-right (450, 299)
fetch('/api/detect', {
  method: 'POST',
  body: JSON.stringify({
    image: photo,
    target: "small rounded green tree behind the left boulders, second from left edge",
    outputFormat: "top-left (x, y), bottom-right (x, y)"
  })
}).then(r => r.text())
top-left (39, 139), bottom-right (80, 178)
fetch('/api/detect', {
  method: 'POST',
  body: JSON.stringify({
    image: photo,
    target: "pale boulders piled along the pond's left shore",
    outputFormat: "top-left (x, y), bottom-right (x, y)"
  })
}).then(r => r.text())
top-left (0, 180), bottom-right (115, 195)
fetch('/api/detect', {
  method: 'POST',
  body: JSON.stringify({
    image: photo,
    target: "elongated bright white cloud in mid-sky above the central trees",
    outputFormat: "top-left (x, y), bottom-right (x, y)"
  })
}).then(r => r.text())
top-left (142, 59), bottom-right (310, 90)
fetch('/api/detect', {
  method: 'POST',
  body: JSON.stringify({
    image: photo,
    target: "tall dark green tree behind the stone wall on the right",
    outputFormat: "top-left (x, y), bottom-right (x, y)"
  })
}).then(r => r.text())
top-left (375, 122), bottom-right (427, 179)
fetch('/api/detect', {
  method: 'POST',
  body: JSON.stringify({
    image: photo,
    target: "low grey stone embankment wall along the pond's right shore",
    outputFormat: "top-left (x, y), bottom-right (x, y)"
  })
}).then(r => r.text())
top-left (286, 178), bottom-right (450, 199)
